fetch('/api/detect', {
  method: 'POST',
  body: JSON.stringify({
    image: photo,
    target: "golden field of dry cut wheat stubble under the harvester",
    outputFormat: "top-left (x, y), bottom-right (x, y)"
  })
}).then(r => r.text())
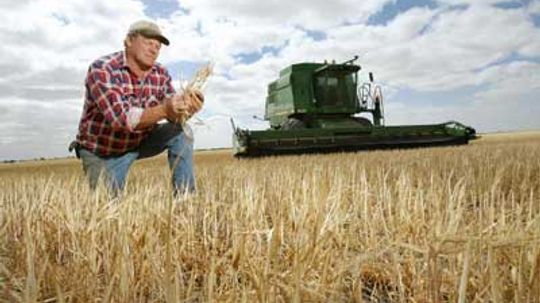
top-left (0, 132), bottom-right (540, 303)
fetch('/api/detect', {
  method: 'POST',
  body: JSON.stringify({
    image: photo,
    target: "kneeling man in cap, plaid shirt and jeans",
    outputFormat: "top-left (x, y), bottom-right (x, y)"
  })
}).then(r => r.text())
top-left (70, 21), bottom-right (203, 194)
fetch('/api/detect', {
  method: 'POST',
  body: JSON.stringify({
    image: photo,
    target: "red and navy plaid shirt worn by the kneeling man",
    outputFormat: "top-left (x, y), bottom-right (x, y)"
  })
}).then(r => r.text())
top-left (77, 51), bottom-right (175, 156)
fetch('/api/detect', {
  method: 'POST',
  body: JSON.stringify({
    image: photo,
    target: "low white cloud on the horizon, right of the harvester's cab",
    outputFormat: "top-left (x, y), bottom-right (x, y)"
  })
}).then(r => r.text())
top-left (386, 62), bottom-right (540, 132)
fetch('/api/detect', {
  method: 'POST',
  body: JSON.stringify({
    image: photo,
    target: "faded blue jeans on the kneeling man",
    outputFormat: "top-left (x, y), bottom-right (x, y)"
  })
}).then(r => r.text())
top-left (79, 123), bottom-right (195, 195)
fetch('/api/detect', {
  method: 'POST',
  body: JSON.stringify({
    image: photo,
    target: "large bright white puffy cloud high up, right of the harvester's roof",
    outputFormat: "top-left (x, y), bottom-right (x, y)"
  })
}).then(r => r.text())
top-left (375, 6), bottom-right (538, 90)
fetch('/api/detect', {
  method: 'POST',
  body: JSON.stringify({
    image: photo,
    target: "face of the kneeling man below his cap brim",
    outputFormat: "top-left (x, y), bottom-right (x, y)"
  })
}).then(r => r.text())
top-left (127, 35), bottom-right (161, 70)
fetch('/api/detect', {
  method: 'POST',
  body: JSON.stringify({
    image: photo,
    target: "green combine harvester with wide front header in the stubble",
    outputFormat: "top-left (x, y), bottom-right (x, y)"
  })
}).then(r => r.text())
top-left (231, 56), bottom-right (476, 157)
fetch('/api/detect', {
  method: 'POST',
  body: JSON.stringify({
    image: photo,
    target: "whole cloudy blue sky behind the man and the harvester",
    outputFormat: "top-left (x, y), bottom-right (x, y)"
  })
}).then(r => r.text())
top-left (0, 0), bottom-right (540, 160)
